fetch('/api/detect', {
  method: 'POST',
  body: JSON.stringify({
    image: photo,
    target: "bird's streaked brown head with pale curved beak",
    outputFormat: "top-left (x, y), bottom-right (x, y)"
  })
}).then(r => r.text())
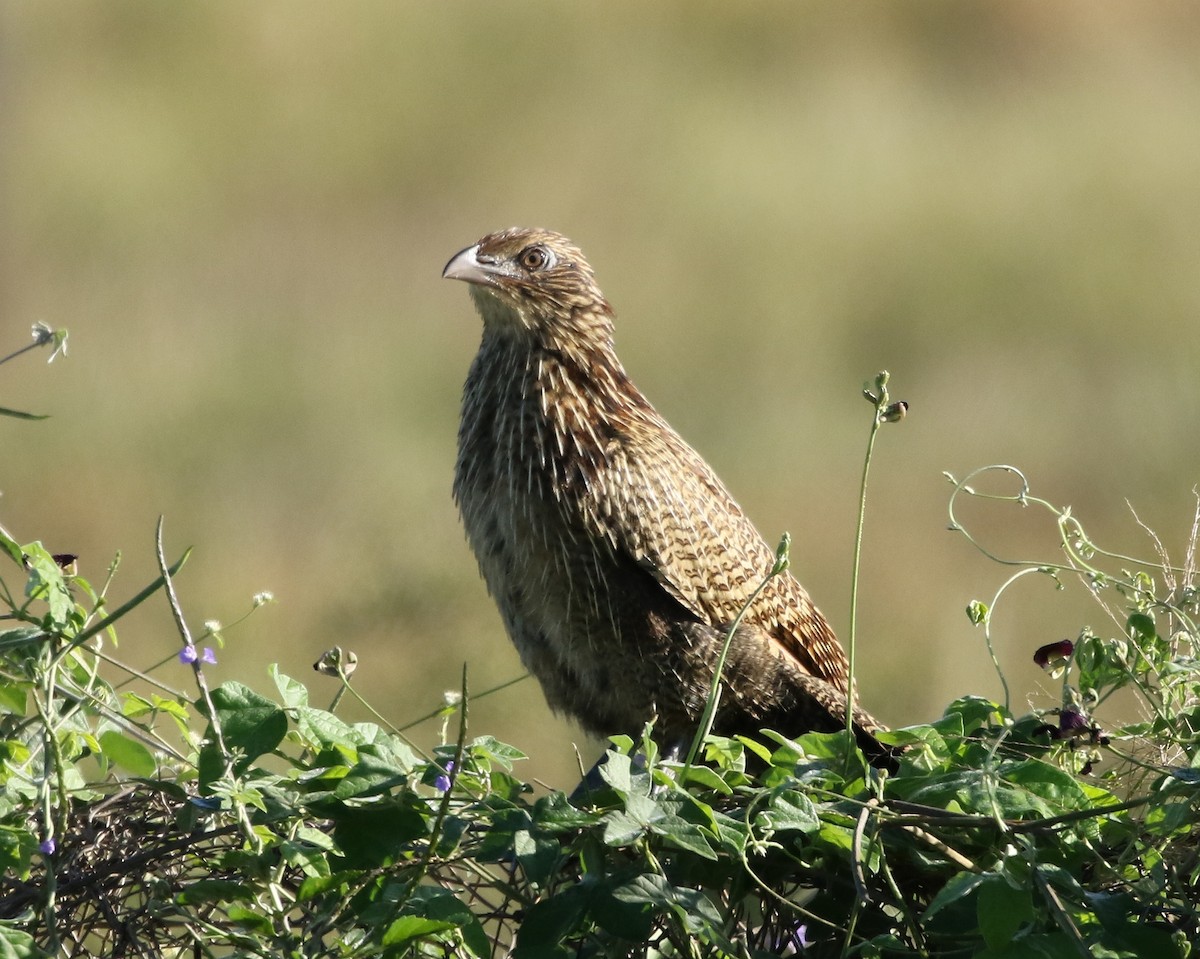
top-left (442, 228), bottom-right (612, 343)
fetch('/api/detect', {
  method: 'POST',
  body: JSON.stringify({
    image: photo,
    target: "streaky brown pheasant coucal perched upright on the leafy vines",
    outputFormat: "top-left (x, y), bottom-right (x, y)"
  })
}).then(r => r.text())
top-left (443, 229), bottom-right (893, 766)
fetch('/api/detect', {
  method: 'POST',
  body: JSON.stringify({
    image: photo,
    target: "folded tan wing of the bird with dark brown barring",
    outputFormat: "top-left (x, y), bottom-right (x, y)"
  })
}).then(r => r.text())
top-left (571, 414), bottom-right (847, 688)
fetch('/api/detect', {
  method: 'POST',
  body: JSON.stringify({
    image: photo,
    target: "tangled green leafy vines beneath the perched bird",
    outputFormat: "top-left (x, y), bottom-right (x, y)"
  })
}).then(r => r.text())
top-left (0, 494), bottom-right (1200, 959)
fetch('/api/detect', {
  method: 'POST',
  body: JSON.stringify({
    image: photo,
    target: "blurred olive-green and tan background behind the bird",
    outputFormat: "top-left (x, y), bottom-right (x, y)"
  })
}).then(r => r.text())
top-left (0, 0), bottom-right (1200, 785)
